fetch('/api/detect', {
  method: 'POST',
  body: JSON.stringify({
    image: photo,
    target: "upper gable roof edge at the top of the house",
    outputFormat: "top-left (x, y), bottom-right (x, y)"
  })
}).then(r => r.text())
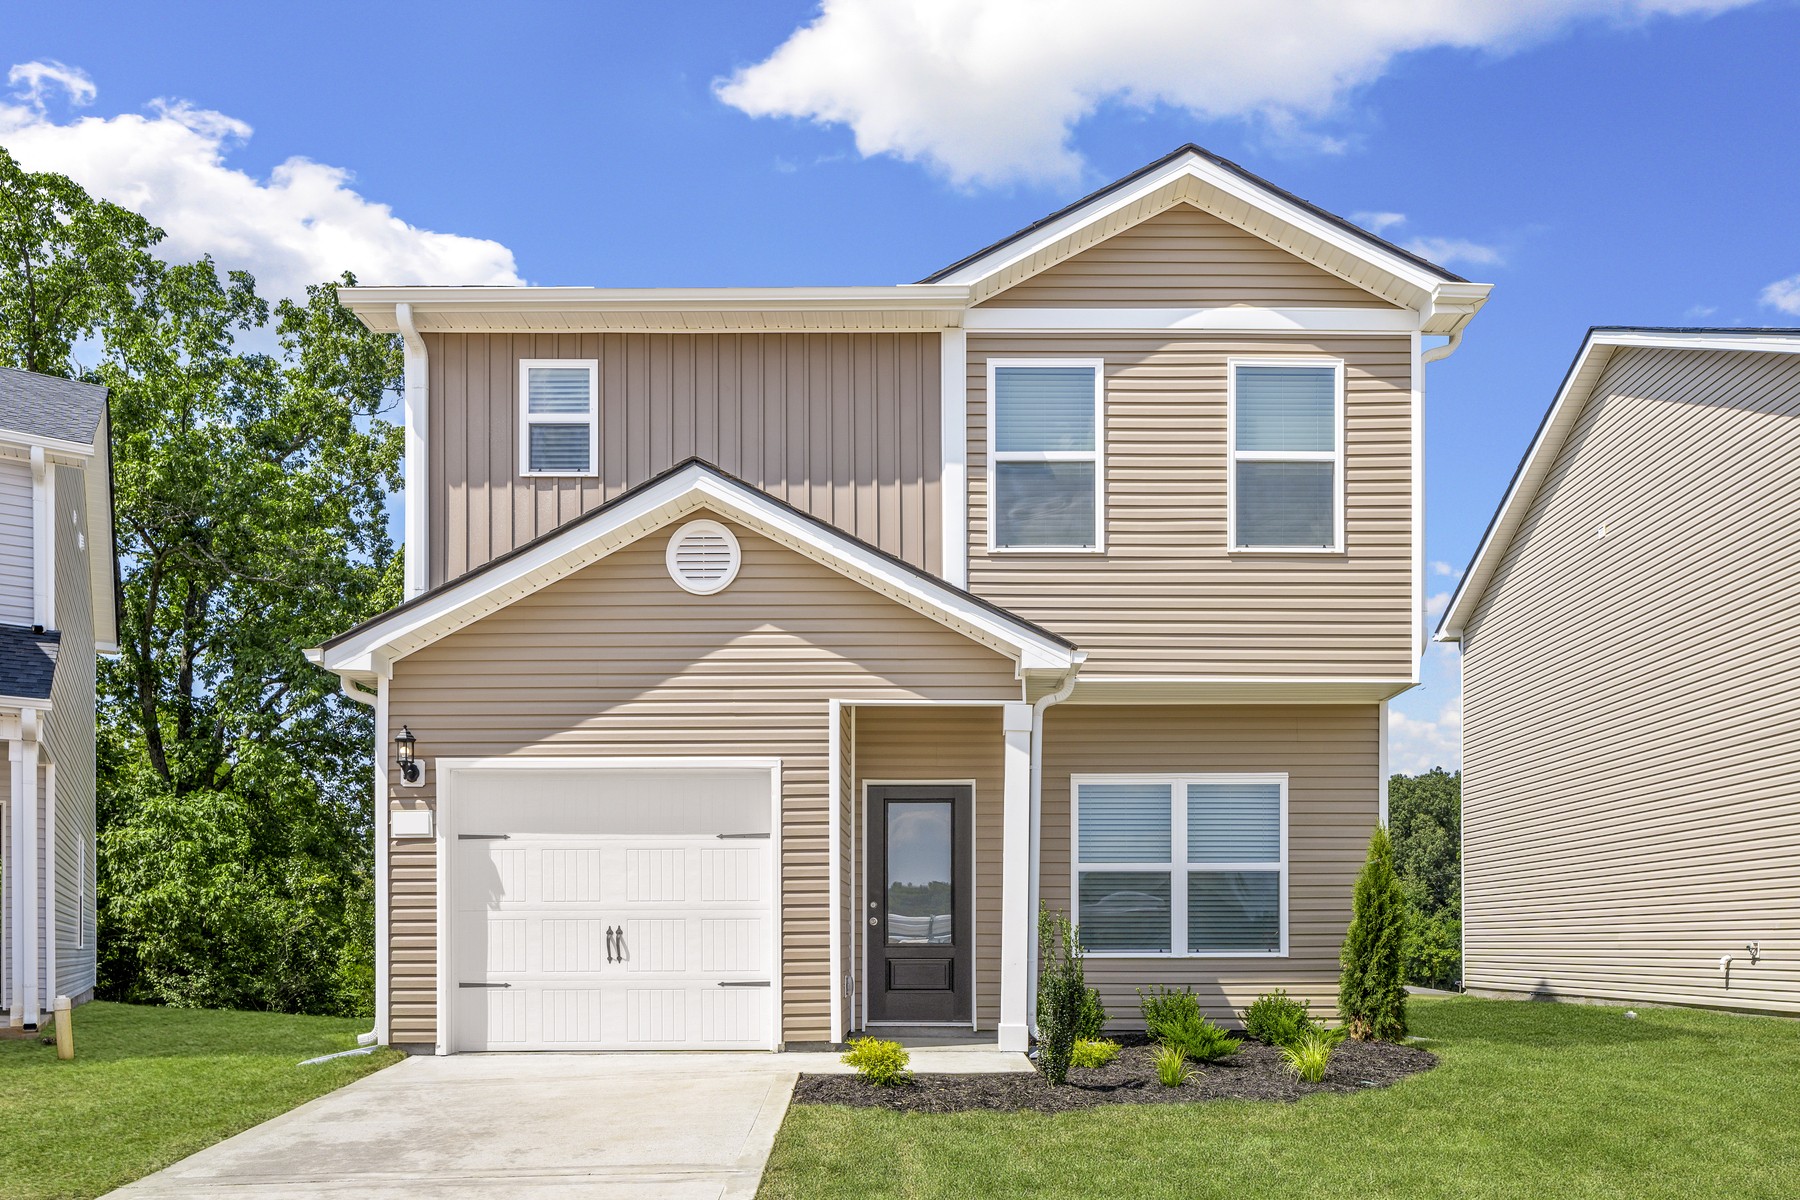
top-left (922, 144), bottom-right (1490, 333)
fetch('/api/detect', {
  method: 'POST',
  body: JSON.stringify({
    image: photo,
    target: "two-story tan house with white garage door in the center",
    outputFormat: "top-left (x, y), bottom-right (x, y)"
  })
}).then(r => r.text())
top-left (310, 146), bottom-right (1489, 1052)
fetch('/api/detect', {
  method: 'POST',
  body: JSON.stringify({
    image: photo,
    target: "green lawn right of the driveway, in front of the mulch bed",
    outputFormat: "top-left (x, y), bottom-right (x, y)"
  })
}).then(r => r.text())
top-left (760, 999), bottom-right (1800, 1200)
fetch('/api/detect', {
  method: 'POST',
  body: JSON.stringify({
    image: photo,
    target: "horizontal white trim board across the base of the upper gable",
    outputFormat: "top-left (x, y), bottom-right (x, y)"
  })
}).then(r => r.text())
top-left (963, 304), bottom-right (1420, 333)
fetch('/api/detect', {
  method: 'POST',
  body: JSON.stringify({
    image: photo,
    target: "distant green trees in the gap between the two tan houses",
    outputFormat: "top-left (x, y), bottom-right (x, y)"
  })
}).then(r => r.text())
top-left (1388, 768), bottom-right (1462, 988)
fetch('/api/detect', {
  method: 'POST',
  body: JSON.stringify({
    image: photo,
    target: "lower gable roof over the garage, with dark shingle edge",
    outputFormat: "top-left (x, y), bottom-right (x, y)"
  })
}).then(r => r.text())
top-left (306, 459), bottom-right (1085, 678)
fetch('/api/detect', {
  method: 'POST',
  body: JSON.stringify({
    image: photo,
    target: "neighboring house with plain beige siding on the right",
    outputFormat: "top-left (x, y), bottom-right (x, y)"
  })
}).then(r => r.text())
top-left (1438, 329), bottom-right (1800, 1013)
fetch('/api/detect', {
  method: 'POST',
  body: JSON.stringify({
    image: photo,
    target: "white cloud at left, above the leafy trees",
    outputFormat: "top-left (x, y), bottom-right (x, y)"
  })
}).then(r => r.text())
top-left (0, 63), bottom-right (520, 297)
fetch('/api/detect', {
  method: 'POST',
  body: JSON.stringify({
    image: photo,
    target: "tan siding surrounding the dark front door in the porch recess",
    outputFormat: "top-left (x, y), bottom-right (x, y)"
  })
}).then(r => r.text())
top-left (851, 707), bottom-right (1006, 1029)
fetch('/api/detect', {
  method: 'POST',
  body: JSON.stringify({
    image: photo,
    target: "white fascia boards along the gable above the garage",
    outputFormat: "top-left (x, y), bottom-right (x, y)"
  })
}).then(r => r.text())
top-left (317, 466), bottom-right (1076, 675)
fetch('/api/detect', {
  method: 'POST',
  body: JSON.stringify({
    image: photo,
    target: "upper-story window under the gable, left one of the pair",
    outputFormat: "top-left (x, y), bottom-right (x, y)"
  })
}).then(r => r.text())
top-left (988, 358), bottom-right (1105, 551)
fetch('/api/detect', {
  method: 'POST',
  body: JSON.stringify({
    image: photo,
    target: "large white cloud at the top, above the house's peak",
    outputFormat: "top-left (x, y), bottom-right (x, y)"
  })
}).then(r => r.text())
top-left (715, 0), bottom-right (1751, 185)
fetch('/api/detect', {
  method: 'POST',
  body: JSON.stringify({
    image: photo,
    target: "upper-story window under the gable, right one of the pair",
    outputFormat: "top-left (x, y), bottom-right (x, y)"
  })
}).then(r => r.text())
top-left (1228, 358), bottom-right (1345, 552)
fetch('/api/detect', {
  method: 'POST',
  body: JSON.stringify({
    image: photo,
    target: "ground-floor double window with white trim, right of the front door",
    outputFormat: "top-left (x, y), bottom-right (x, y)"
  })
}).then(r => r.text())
top-left (1071, 775), bottom-right (1287, 957)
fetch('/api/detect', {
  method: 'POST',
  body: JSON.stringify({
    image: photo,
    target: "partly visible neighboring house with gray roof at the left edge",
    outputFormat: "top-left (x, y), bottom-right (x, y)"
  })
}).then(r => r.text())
top-left (0, 369), bottom-right (119, 1027)
